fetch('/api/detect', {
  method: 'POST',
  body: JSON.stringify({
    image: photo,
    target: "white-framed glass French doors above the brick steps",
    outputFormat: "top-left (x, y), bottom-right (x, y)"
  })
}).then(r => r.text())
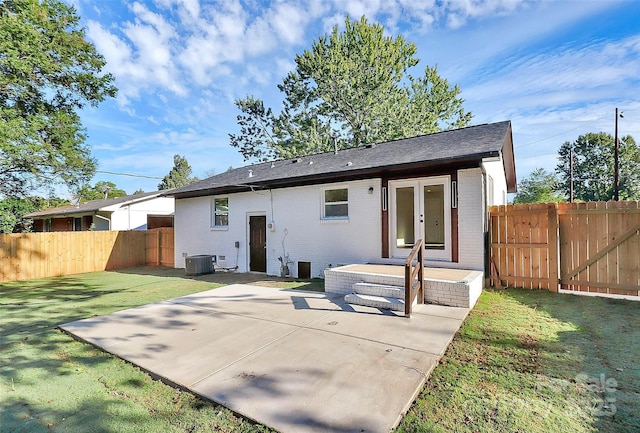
top-left (389, 176), bottom-right (451, 260)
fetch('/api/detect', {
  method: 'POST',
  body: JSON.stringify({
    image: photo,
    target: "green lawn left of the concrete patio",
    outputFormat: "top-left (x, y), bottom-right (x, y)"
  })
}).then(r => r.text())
top-left (0, 268), bottom-right (284, 433)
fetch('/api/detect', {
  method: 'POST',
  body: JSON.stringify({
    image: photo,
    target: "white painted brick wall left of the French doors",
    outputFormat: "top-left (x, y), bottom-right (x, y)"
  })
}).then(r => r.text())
top-left (175, 179), bottom-right (382, 277)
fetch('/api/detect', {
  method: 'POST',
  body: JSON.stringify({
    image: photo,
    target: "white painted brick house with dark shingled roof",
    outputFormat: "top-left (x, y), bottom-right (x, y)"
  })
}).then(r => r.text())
top-left (170, 121), bottom-right (516, 277)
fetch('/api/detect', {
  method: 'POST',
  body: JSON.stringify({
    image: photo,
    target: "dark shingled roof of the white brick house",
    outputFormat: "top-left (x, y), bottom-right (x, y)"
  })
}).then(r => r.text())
top-left (165, 121), bottom-right (516, 198)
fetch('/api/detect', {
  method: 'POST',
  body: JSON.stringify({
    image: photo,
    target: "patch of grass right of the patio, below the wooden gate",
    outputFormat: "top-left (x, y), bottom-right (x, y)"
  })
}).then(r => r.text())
top-left (397, 289), bottom-right (640, 433)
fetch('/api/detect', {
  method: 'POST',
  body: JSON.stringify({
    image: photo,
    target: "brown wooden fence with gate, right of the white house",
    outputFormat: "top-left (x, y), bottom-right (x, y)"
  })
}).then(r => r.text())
top-left (489, 201), bottom-right (640, 296)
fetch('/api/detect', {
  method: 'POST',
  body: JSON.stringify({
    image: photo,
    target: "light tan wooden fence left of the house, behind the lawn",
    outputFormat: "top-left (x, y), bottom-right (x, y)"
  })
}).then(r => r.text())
top-left (0, 228), bottom-right (173, 282)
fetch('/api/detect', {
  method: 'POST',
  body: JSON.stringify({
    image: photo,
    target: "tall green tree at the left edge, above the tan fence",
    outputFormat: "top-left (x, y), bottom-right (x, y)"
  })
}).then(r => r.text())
top-left (0, 0), bottom-right (117, 197)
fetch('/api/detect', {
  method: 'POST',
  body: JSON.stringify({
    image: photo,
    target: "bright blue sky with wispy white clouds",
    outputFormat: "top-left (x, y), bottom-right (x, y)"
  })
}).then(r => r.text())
top-left (63, 0), bottom-right (640, 193)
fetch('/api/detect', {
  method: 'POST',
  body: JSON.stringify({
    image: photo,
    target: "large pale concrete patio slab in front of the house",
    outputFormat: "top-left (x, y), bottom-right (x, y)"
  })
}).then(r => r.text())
top-left (61, 284), bottom-right (468, 432)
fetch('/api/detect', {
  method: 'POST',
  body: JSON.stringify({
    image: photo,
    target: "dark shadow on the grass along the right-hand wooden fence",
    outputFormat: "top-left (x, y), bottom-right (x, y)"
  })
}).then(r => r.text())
top-left (492, 289), bottom-right (640, 432)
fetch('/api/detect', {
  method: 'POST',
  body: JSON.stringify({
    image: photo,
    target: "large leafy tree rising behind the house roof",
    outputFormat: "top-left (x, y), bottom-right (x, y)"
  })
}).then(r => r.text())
top-left (229, 17), bottom-right (471, 161)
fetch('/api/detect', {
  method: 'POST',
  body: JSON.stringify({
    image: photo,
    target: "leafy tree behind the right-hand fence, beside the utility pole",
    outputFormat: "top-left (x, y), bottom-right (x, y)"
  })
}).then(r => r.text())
top-left (556, 132), bottom-right (640, 201)
